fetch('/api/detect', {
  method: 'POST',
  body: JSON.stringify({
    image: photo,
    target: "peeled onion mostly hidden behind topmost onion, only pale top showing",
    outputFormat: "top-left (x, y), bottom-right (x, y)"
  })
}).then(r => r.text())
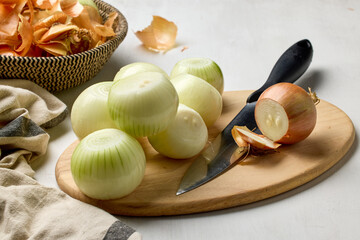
top-left (114, 62), bottom-right (169, 82)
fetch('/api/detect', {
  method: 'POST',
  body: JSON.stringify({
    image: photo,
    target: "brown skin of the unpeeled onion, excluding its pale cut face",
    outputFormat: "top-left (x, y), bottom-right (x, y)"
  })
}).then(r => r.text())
top-left (255, 83), bottom-right (317, 144)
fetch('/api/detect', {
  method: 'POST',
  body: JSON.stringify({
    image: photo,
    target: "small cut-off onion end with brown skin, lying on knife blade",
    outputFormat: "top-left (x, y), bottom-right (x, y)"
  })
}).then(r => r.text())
top-left (231, 126), bottom-right (281, 150)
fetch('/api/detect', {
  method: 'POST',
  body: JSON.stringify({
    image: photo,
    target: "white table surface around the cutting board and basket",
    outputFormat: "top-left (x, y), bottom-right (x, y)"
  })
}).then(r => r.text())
top-left (33, 0), bottom-right (360, 240)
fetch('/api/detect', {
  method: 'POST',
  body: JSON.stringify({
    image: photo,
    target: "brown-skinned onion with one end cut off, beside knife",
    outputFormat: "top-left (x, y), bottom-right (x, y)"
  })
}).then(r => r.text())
top-left (255, 83), bottom-right (318, 144)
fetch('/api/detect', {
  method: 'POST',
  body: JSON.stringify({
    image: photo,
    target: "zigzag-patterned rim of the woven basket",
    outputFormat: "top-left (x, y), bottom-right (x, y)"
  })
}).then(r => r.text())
top-left (0, 0), bottom-right (128, 61)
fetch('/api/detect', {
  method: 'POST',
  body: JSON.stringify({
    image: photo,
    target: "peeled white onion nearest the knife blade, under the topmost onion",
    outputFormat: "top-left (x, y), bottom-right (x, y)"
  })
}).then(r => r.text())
top-left (148, 104), bottom-right (208, 159)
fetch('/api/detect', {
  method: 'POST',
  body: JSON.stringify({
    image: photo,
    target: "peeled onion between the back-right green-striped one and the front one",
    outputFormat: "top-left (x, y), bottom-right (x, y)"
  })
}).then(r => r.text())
top-left (171, 74), bottom-right (222, 127)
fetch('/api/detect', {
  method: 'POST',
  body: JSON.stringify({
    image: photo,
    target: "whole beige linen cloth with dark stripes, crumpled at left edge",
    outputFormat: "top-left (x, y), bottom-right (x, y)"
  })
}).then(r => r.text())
top-left (0, 80), bottom-right (141, 240)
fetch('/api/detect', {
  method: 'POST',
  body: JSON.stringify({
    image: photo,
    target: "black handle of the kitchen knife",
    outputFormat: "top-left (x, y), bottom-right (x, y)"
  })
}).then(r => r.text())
top-left (246, 39), bottom-right (313, 103)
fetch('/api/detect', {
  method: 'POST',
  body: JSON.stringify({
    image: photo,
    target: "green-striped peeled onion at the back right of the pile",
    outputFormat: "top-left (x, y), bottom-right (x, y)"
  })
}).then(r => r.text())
top-left (170, 58), bottom-right (224, 94)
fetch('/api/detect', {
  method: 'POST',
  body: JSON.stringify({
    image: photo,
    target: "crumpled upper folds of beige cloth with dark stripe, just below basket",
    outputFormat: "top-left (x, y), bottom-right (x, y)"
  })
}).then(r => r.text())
top-left (0, 80), bottom-right (67, 176)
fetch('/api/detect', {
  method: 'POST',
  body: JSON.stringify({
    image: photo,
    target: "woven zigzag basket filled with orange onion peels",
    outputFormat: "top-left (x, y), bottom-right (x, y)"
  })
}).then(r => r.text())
top-left (0, 0), bottom-right (128, 92)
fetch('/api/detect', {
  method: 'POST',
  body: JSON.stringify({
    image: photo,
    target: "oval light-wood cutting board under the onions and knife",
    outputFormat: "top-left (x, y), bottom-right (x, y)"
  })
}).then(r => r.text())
top-left (55, 91), bottom-right (355, 216)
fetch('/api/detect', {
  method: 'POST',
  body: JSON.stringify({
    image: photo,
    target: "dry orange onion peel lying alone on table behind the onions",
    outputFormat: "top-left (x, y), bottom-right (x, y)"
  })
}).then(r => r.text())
top-left (135, 16), bottom-right (177, 51)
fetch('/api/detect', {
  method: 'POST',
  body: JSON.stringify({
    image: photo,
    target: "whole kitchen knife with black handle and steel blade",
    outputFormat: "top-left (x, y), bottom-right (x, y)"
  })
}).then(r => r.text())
top-left (176, 39), bottom-right (313, 195)
